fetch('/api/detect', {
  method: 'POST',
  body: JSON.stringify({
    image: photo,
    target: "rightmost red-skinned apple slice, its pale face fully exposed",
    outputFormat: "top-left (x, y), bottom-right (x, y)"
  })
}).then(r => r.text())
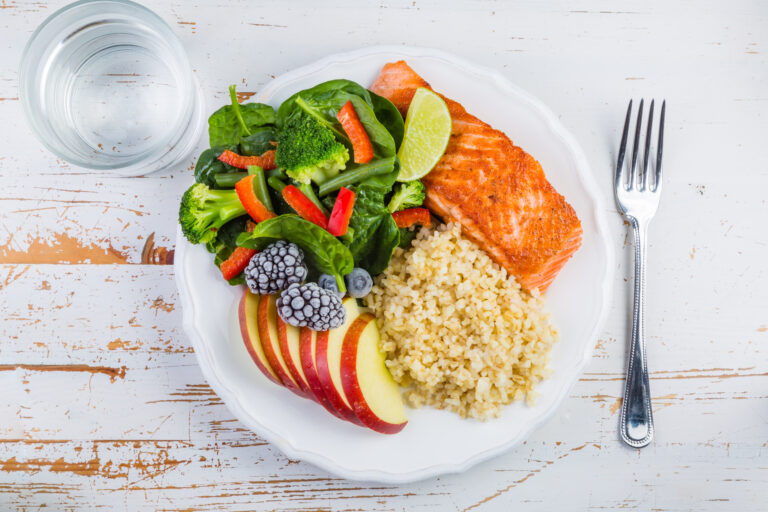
top-left (341, 313), bottom-right (408, 434)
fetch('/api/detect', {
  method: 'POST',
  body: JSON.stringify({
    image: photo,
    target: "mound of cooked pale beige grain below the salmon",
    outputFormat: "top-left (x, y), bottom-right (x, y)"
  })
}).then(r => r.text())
top-left (366, 224), bottom-right (557, 419)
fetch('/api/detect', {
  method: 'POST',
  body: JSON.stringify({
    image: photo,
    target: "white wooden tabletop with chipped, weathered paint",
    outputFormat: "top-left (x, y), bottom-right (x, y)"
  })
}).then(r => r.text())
top-left (0, 0), bottom-right (768, 511)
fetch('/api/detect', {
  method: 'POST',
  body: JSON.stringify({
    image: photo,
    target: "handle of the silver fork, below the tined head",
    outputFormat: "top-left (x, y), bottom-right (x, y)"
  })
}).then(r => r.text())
top-left (619, 218), bottom-right (653, 448)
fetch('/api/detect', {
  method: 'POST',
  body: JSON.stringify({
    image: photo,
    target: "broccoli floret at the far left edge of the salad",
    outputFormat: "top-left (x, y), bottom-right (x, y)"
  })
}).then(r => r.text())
top-left (179, 183), bottom-right (245, 244)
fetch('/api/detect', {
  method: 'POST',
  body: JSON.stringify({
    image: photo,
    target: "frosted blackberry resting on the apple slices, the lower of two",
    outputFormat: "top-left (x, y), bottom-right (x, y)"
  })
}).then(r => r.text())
top-left (277, 283), bottom-right (347, 331)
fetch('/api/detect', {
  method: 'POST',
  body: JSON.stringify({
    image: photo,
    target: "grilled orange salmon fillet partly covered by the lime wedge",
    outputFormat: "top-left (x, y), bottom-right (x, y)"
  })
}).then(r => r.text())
top-left (371, 61), bottom-right (582, 292)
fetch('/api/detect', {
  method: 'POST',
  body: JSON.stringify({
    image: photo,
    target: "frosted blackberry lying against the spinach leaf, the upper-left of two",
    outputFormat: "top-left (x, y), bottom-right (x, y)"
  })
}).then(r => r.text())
top-left (245, 240), bottom-right (307, 295)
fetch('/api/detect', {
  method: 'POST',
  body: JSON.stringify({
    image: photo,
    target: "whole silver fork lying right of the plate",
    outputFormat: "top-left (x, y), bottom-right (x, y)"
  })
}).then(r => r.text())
top-left (614, 100), bottom-right (666, 448)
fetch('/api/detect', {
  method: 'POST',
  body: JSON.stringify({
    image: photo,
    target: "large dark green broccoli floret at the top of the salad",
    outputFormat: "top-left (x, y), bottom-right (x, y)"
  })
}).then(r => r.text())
top-left (275, 111), bottom-right (349, 185)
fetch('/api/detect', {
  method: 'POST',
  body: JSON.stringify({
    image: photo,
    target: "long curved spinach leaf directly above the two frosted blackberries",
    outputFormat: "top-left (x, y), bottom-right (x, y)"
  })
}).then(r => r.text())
top-left (237, 214), bottom-right (355, 290)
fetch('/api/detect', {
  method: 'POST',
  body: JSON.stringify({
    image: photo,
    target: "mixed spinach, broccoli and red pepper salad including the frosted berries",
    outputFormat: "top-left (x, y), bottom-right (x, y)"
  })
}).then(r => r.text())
top-left (179, 80), bottom-right (431, 330)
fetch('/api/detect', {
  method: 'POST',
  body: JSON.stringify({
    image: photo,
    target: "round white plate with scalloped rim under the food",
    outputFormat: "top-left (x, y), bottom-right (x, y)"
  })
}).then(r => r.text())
top-left (175, 47), bottom-right (613, 483)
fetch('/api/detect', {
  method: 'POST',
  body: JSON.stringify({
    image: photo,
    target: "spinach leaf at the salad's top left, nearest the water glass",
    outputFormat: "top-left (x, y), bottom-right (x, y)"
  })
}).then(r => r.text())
top-left (208, 99), bottom-right (275, 148)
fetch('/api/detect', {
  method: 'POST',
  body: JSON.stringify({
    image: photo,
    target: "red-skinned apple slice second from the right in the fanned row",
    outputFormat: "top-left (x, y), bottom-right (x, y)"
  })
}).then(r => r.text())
top-left (315, 297), bottom-right (363, 425)
